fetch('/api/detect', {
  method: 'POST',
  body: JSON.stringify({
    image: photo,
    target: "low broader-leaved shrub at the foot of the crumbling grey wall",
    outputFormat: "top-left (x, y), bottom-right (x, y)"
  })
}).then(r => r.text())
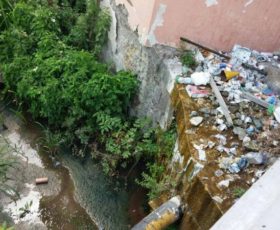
top-left (93, 119), bottom-right (158, 173)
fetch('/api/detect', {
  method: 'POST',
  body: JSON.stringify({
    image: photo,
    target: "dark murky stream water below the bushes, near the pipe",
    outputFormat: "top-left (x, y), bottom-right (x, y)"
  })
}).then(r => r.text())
top-left (21, 119), bottom-right (145, 230)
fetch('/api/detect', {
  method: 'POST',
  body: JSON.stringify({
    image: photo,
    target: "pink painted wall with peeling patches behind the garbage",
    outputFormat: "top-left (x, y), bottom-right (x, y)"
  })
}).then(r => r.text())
top-left (117, 0), bottom-right (280, 51)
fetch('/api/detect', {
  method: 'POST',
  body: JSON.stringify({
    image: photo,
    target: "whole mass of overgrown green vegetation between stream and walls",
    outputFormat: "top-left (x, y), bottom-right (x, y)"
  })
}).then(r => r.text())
top-left (0, 0), bottom-right (175, 197)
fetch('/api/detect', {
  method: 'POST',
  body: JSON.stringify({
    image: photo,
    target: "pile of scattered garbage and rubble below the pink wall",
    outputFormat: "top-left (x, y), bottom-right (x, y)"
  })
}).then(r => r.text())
top-left (176, 45), bottom-right (280, 174)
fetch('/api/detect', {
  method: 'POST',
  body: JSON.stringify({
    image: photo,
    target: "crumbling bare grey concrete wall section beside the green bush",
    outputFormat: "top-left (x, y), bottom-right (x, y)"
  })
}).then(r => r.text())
top-left (102, 0), bottom-right (182, 129)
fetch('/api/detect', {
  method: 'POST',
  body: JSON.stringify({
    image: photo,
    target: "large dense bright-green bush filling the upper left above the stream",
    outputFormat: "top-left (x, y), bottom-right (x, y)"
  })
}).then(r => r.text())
top-left (0, 1), bottom-right (138, 147)
